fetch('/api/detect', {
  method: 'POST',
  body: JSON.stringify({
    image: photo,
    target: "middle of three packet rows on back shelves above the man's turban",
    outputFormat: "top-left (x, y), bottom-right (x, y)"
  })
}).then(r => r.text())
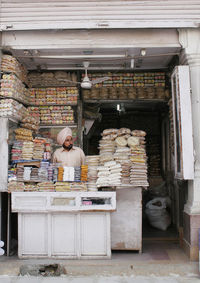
top-left (30, 87), bottom-right (78, 105)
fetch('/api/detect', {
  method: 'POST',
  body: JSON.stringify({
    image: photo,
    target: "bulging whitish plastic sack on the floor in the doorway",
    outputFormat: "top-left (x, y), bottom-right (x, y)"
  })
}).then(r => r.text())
top-left (145, 198), bottom-right (171, 231)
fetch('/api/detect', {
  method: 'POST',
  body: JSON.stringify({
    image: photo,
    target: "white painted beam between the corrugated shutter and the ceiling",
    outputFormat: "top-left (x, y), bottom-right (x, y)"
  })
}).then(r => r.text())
top-left (2, 29), bottom-right (180, 51)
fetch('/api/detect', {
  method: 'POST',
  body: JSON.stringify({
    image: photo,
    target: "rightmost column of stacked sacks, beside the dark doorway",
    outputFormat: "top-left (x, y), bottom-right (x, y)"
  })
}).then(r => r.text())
top-left (128, 130), bottom-right (149, 187)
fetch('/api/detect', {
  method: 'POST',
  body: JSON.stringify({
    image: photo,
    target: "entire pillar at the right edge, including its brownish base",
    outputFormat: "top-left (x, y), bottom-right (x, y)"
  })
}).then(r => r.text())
top-left (179, 29), bottom-right (200, 260)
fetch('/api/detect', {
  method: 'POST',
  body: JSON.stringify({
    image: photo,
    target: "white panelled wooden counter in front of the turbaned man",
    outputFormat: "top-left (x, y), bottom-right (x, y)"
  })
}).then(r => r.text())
top-left (11, 192), bottom-right (116, 259)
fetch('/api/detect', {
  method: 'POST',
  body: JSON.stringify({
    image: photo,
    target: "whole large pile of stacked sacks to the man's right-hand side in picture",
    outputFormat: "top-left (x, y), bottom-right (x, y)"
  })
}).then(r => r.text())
top-left (96, 128), bottom-right (148, 187)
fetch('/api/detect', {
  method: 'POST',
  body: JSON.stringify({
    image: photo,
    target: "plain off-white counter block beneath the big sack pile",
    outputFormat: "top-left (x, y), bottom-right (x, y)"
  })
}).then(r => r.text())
top-left (111, 189), bottom-right (142, 252)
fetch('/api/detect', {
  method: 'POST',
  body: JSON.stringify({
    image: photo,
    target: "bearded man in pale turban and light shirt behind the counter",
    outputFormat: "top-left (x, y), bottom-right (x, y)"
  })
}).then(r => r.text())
top-left (53, 127), bottom-right (85, 167)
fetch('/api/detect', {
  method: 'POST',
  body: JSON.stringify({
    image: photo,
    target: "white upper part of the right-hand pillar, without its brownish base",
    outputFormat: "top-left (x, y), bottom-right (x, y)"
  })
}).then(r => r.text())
top-left (179, 29), bottom-right (200, 214)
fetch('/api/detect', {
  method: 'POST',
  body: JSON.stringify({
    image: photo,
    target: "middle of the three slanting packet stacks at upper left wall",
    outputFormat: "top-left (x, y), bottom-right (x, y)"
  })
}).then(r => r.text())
top-left (0, 74), bottom-right (29, 104)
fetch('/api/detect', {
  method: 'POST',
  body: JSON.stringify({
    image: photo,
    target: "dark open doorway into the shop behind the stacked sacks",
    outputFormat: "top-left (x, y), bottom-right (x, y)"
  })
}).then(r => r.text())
top-left (83, 79), bottom-right (183, 244)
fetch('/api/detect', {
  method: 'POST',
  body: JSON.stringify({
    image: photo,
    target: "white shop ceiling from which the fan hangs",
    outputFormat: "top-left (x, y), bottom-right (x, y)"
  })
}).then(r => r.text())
top-left (9, 47), bottom-right (181, 71)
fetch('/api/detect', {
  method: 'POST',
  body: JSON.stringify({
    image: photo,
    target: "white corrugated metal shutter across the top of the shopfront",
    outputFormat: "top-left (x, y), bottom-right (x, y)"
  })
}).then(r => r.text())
top-left (0, 0), bottom-right (200, 30)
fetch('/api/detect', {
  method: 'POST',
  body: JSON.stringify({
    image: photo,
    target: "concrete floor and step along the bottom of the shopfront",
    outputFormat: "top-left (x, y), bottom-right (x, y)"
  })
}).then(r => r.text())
top-left (0, 240), bottom-right (200, 283)
